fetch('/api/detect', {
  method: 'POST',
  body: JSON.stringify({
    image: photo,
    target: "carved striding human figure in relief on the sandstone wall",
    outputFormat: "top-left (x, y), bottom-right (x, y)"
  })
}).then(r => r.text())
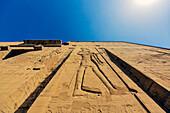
top-left (73, 48), bottom-right (115, 96)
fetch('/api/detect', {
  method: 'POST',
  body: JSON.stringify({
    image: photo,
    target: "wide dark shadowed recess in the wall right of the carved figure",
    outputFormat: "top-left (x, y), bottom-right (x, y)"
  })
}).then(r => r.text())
top-left (105, 49), bottom-right (170, 113)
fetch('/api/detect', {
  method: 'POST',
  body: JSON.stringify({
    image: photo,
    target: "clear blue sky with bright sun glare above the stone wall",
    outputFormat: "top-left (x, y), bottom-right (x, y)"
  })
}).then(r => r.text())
top-left (0, 0), bottom-right (170, 48)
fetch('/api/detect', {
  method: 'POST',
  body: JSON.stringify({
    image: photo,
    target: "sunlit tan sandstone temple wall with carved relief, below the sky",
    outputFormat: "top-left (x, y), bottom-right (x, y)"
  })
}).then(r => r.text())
top-left (0, 42), bottom-right (170, 113)
